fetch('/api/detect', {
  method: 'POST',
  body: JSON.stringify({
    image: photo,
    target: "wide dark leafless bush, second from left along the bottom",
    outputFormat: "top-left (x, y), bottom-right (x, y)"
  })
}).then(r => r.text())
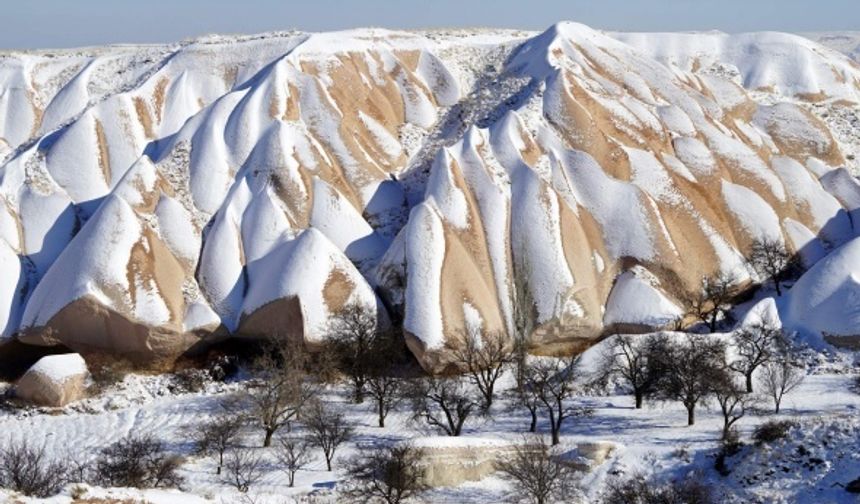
top-left (95, 434), bottom-right (182, 488)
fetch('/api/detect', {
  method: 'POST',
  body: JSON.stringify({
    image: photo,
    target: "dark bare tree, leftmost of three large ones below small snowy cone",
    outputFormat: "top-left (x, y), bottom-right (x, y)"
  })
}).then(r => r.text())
top-left (598, 335), bottom-right (665, 409)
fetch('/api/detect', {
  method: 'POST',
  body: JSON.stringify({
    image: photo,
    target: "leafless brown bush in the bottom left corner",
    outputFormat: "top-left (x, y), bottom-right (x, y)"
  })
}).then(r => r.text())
top-left (0, 442), bottom-right (68, 498)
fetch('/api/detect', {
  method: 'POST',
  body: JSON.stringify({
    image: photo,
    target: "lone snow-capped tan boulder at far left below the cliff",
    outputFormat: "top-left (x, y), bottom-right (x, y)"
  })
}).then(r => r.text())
top-left (15, 353), bottom-right (89, 407)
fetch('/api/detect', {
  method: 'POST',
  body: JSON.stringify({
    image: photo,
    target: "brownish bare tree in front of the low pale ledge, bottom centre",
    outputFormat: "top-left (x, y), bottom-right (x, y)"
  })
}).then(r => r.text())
top-left (496, 436), bottom-right (574, 504)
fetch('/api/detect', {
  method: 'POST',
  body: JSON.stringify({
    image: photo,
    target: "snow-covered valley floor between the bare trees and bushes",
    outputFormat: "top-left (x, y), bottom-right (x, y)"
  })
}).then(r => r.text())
top-left (0, 340), bottom-right (860, 503)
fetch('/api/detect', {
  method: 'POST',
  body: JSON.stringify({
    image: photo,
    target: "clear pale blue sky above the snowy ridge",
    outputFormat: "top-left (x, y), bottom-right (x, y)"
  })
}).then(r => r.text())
top-left (0, 0), bottom-right (860, 49)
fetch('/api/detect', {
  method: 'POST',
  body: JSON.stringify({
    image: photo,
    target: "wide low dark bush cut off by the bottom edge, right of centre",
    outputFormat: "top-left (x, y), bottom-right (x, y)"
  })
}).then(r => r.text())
top-left (602, 476), bottom-right (717, 504)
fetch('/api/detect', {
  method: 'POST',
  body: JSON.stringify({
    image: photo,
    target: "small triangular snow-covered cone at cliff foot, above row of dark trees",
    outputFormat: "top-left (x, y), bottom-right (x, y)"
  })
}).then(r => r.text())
top-left (603, 266), bottom-right (683, 329)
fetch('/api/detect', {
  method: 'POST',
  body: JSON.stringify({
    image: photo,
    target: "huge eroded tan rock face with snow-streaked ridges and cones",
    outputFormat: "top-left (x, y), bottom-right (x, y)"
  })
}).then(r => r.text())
top-left (0, 23), bottom-right (860, 371)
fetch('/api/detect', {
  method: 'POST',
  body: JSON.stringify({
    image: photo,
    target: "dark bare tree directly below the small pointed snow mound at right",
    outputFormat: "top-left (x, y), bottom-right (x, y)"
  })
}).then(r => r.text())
top-left (730, 320), bottom-right (788, 392)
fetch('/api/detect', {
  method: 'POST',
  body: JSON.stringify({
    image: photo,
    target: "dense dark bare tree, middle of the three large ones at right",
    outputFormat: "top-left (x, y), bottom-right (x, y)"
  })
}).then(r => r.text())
top-left (658, 334), bottom-right (725, 425)
